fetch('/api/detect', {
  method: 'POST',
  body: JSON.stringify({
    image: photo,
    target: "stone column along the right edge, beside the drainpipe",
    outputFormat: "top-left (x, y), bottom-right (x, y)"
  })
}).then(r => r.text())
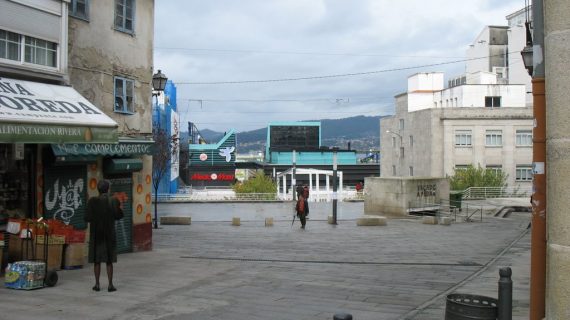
top-left (535, 0), bottom-right (570, 319)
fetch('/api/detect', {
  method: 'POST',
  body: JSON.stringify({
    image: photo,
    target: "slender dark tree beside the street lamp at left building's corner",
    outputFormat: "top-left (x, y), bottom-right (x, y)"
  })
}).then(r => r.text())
top-left (152, 125), bottom-right (179, 229)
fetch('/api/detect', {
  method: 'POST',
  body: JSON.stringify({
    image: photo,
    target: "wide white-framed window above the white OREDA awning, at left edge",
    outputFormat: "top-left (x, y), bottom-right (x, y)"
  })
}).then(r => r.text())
top-left (0, 30), bottom-right (58, 68)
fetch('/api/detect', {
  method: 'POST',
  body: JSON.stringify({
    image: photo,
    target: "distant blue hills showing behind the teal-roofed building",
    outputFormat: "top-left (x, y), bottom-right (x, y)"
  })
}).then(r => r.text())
top-left (183, 116), bottom-right (381, 154)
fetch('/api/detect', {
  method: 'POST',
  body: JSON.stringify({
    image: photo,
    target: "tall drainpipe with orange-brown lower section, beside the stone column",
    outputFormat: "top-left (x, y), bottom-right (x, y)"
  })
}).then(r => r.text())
top-left (529, 0), bottom-right (546, 320)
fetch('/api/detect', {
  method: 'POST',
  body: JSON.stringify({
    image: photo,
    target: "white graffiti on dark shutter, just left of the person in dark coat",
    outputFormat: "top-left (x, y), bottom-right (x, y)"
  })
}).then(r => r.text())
top-left (45, 178), bottom-right (84, 224)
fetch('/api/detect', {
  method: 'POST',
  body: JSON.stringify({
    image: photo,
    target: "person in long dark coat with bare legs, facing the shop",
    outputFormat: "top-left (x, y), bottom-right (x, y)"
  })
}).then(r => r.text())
top-left (85, 180), bottom-right (123, 292)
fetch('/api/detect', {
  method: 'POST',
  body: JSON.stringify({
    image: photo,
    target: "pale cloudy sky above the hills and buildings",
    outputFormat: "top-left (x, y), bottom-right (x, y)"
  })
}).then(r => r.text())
top-left (154, 0), bottom-right (524, 132)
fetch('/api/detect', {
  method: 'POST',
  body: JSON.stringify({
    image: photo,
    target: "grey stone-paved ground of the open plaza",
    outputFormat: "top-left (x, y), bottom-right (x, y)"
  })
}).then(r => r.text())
top-left (0, 204), bottom-right (530, 320)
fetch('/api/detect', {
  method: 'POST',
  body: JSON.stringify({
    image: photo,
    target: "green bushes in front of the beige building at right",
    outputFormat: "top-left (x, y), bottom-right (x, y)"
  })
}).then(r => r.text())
top-left (449, 165), bottom-right (508, 190)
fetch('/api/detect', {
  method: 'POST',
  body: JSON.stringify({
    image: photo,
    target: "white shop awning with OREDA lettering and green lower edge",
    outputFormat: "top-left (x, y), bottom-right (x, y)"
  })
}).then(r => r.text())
top-left (0, 78), bottom-right (118, 143)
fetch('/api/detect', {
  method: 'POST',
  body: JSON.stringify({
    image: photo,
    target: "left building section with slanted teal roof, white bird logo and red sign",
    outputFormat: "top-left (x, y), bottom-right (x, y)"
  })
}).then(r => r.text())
top-left (188, 130), bottom-right (236, 187)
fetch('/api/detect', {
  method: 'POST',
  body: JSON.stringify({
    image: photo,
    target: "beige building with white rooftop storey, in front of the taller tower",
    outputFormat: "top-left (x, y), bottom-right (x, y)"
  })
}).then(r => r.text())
top-left (380, 72), bottom-right (533, 186)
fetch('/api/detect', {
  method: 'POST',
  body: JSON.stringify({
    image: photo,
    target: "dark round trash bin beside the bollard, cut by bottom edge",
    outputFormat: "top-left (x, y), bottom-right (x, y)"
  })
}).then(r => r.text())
top-left (445, 293), bottom-right (498, 320)
